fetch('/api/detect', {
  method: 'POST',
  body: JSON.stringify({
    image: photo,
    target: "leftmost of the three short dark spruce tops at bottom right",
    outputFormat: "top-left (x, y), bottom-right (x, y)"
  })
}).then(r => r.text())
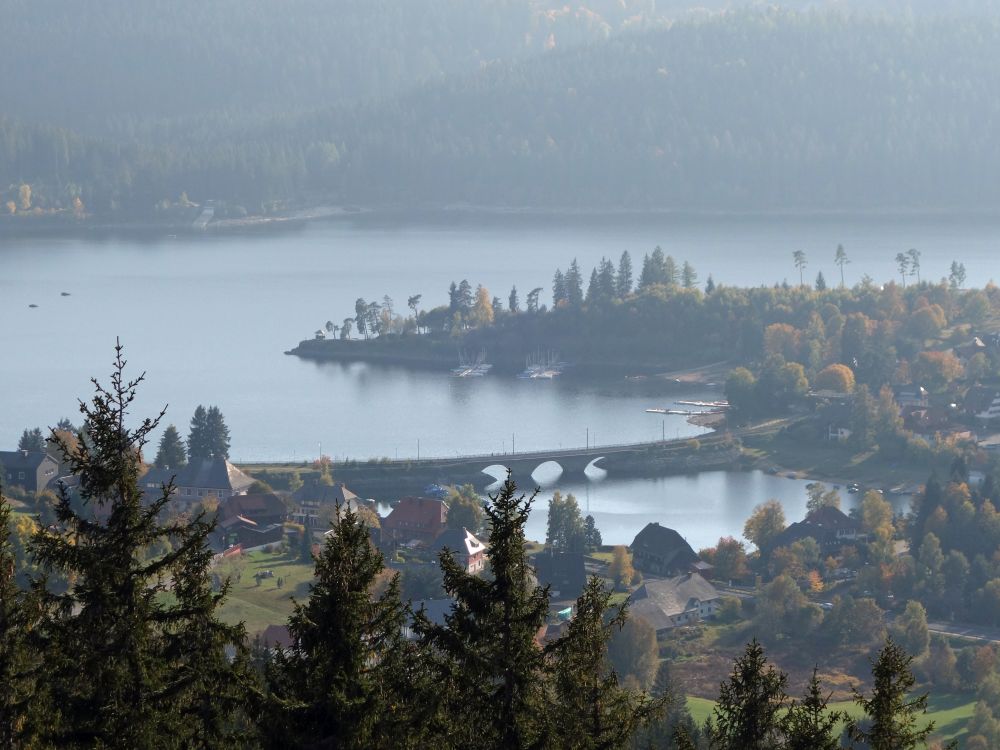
top-left (710, 638), bottom-right (788, 750)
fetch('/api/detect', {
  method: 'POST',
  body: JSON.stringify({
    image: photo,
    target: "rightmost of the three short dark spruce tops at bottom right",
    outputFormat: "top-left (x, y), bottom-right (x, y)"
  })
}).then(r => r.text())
top-left (847, 638), bottom-right (934, 750)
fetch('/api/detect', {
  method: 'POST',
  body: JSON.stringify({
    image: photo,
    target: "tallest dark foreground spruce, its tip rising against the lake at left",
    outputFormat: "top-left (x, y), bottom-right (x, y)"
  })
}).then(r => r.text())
top-left (29, 345), bottom-right (254, 750)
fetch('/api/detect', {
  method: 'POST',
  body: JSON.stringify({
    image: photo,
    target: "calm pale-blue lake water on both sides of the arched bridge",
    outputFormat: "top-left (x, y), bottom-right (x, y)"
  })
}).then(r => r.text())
top-left (0, 216), bottom-right (984, 544)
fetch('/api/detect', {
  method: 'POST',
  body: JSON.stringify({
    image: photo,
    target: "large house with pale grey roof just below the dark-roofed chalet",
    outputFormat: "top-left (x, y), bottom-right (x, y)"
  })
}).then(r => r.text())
top-left (628, 573), bottom-right (722, 637)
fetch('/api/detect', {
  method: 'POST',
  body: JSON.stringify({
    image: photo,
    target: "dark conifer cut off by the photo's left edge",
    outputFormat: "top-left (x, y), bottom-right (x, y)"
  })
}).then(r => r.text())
top-left (0, 488), bottom-right (34, 747)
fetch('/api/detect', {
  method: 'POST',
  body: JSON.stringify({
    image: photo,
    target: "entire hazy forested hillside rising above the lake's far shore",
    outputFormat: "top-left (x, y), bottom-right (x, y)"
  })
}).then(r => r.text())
top-left (0, 0), bottom-right (1000, 217)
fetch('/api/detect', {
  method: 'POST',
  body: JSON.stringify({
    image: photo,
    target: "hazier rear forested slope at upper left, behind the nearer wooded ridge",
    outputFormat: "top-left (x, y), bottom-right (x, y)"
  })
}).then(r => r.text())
top-left (0, 0), bottom-right (672, 128)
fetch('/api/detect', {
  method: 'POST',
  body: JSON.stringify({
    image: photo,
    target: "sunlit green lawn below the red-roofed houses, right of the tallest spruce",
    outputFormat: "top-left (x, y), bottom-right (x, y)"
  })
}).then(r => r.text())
top-left (218, 551), bottom-right (313, 636)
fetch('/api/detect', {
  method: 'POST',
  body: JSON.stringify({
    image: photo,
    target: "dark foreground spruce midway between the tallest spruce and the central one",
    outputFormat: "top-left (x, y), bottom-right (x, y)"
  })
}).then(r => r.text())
top-left (270, 508), bottom-right (416, 750)
